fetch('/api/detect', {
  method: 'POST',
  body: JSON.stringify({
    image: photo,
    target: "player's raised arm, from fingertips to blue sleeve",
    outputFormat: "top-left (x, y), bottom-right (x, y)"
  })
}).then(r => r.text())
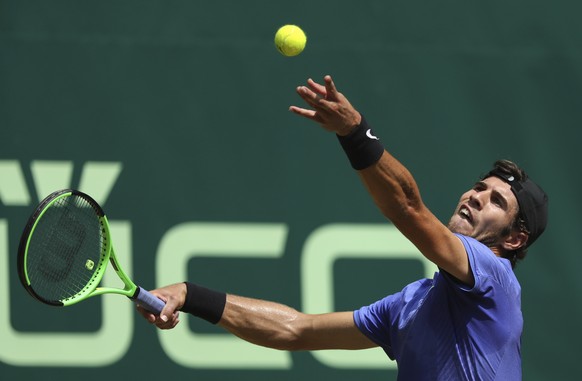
top-left (290, 76), bottom-right (474, 285)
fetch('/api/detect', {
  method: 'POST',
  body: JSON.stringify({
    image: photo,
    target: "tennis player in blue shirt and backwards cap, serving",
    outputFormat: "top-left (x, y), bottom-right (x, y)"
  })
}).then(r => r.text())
top-left (138, 76), bottom-right (548, 381)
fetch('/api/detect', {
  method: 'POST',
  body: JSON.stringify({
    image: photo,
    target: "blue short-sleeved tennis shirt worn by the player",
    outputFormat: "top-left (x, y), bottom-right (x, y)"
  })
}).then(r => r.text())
top-left (354, 235), bottom-right (523, 381)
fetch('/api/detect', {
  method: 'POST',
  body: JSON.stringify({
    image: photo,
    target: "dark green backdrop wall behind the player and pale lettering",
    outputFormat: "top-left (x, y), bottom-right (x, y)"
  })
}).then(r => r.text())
top-left (0, 0), bottom-right (582, 380)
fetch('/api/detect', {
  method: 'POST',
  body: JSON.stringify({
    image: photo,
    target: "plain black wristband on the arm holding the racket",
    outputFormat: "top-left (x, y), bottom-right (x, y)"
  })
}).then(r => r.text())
top-left (181, 282), bottom-right (226, 324)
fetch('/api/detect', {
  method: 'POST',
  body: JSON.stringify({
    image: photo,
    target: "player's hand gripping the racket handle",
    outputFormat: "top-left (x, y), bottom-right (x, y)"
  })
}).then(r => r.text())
top-left (137, 283), bottom-right (186, 329)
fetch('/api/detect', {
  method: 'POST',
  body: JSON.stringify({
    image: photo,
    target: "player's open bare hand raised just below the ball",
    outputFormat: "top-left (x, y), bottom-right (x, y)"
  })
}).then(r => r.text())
top-left (289, 75), bottom-right (362, 136)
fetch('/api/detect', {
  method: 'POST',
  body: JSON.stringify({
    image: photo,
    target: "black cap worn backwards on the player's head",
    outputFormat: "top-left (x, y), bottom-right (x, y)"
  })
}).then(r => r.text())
top-left (483, 167), bottom-right (548, 247)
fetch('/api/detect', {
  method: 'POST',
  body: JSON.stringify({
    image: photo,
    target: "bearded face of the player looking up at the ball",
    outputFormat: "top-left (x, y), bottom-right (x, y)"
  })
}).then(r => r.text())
top-left (448, 176), bottom-right (518, 247)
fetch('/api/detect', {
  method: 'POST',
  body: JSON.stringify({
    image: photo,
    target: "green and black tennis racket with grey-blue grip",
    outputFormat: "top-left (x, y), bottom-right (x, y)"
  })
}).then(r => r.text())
top-left (18, 189), bottom-right (165, 315)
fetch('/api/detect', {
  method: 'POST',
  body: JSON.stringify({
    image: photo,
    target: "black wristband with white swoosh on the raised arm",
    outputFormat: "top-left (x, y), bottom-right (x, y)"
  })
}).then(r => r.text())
top-left (337, 115), bottom-right (384, 170)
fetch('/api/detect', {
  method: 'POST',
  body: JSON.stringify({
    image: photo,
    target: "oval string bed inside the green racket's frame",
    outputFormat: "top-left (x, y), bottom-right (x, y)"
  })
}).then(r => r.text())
top-left (27, 195), bottom-right (107, 301)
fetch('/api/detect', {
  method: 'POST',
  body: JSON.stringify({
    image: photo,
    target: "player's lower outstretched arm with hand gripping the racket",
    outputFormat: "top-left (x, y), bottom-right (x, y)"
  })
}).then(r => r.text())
top-left (138, 283), bottom-right (376, 350)
